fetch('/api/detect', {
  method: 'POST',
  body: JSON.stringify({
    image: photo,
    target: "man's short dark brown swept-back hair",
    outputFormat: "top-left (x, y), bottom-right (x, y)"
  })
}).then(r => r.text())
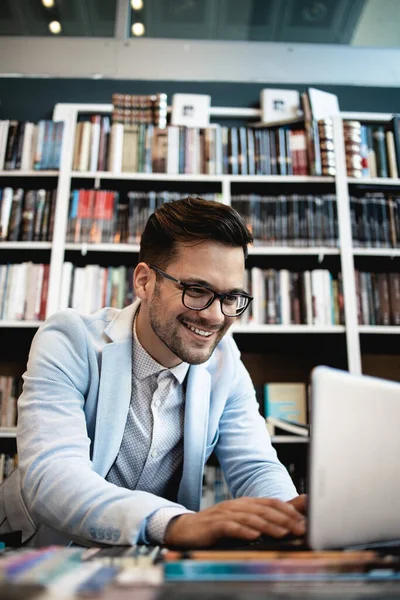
top-left (139, 196), bottom-right (253, 269)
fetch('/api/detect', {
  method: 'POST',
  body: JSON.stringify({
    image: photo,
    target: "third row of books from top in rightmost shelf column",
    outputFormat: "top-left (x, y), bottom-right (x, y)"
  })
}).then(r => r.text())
top-left (355, 271), bottom-right (400, 326)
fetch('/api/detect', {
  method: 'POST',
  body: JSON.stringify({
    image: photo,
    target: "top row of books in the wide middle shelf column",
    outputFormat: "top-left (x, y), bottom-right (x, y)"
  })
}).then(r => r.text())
top-left (72, 115), bottom-right (320, 175)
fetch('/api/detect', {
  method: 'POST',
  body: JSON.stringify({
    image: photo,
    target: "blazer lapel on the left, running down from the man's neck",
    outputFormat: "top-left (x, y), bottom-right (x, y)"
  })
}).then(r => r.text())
top-left (92, 302), bottom-right (139, 477)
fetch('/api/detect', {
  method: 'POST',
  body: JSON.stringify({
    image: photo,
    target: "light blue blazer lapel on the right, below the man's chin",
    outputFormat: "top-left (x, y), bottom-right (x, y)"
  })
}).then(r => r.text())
top-left (178, 363), bottom-right (211, 511)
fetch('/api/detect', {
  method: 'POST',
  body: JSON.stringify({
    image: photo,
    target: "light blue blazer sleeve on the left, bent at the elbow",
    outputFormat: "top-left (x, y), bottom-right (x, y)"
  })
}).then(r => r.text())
top-left (17, 310), bottom-right (188, 544)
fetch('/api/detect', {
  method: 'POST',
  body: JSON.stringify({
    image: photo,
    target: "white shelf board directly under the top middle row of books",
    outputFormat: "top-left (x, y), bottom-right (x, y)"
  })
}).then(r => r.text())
top-left (71, 171), bottom-right (335, 183)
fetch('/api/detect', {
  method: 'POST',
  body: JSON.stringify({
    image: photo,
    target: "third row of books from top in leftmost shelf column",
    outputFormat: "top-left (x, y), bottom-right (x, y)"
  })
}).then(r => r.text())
top-left (0, 262), bottom-right (50, 321)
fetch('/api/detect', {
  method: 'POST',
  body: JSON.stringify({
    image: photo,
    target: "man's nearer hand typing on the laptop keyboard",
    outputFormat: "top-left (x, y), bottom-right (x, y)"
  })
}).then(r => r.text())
top-left (164, 497), bottom-right (305, 548)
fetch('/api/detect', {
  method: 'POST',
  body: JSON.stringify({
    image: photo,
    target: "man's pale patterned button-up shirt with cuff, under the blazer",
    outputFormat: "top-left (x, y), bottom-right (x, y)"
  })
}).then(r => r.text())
top-left (106, 319), bottom-right (190, 543)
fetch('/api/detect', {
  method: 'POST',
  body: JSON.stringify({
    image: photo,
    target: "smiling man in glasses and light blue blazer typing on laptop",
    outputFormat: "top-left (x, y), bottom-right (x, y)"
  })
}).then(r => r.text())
top-left (0, 198), bottom-right (305, 546)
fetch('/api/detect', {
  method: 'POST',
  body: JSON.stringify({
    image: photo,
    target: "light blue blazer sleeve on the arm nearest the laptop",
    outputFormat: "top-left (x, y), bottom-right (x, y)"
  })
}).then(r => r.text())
top-left (215, 340), bottom-right (298, 501)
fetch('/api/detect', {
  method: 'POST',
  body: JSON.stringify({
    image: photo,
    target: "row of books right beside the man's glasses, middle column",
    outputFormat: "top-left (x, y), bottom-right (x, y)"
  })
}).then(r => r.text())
top-left (240, 267), bottom-right (344, 326)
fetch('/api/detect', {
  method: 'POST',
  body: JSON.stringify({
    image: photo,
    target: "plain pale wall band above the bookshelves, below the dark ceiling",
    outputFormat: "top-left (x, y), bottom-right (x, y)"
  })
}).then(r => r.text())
top-left (0, 36), bottom-right (400, 87)
